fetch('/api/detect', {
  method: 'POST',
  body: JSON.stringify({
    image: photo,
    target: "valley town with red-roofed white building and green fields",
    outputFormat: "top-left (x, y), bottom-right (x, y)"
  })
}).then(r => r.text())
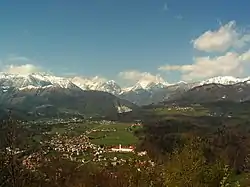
top-left (23, 119), bottom-right (147, 170)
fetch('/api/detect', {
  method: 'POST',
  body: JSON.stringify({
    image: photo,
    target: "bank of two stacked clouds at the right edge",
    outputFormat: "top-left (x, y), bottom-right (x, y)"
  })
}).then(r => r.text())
top-left (158, 21), bottom-right (250, 81)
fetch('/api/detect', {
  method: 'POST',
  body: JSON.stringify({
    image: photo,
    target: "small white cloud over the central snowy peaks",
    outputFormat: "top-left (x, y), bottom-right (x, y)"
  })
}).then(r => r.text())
top-left (119, 70), bottom-right (164, 83)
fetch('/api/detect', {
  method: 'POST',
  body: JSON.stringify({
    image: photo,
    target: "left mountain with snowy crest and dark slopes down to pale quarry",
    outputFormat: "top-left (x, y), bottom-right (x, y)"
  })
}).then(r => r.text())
top-left (0, 73), bottom-right (142, 119)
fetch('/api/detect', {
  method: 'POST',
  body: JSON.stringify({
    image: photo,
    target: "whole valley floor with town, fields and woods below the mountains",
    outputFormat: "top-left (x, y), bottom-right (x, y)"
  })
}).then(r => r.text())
top-left (0, 102), bottom-right (250, 187)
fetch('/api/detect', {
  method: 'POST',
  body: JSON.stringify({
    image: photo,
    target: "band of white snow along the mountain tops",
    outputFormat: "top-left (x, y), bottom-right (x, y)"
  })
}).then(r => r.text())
top-left (0, 73), bottom-right (250, 97)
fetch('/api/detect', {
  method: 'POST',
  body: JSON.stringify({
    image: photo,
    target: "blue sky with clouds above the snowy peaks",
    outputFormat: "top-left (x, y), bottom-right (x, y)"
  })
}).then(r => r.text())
top-left (0, 0), bottom-right (250, 84)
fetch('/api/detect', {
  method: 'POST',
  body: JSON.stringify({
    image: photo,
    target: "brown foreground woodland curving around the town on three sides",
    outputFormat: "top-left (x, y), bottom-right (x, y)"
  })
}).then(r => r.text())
top-left (0, 115), bottom-right (250, 187)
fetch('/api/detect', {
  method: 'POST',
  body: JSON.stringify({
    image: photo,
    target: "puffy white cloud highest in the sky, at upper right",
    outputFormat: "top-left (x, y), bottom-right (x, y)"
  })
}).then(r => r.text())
top-left (191, 21), bottom-right (250, 52)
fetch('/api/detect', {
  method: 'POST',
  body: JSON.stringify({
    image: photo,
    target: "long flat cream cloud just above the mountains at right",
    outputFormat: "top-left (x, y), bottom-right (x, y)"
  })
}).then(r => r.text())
top-left (158, 50), bottom-right (250, 81)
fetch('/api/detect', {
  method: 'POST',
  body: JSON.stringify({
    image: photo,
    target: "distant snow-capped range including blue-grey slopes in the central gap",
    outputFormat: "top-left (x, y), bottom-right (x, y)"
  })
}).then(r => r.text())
top-left (0, 73), bottom-right (250, 105)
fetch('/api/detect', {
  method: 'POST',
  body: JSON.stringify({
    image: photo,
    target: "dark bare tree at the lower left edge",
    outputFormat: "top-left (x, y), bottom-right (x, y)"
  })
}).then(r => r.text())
top-left (0, 116), bottom-right (38, 187)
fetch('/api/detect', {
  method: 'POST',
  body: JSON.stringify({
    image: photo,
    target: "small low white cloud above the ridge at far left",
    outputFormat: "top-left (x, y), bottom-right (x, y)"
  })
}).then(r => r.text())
top-left (3, 64), bottom-right (42, 74)
